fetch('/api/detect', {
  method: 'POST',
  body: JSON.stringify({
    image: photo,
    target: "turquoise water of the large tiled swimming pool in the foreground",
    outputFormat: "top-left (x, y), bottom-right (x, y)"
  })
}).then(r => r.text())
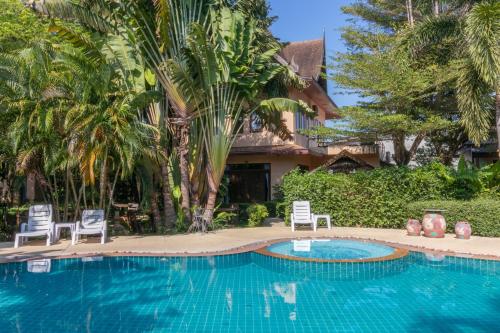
top-left (0, 253), bottom-right (500, 333)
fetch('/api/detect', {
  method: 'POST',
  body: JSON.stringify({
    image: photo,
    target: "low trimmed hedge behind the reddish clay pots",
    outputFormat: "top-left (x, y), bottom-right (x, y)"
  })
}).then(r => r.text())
top-left (407, 199), bottom-right (500, 237)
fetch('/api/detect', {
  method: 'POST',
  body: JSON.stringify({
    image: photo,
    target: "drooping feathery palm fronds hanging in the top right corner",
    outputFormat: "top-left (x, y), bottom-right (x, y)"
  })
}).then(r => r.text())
top-left (405, 0), bottom-right (500, 154)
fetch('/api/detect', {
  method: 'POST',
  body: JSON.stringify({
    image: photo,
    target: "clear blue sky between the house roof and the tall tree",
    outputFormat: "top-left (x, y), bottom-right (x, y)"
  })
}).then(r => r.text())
top-left (268, 0), bottom-right (358, 106)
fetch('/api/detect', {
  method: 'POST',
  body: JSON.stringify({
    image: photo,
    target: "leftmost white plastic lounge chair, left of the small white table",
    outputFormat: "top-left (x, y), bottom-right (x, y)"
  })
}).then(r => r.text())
top-left (14, 205), bottom-right (54, 248)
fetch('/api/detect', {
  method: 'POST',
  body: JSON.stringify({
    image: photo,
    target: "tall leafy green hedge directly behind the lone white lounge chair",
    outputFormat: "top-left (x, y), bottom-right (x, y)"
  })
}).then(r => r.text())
top-left (283, 168), bottom-right (447, 228)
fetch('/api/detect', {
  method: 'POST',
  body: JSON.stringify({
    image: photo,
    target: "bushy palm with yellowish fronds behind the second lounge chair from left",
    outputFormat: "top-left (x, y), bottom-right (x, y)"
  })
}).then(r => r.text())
top-left (59, 45), bottom-right (156, 208)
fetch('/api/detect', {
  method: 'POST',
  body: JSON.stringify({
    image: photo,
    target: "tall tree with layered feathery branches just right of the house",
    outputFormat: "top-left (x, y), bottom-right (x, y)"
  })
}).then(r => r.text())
top-left (326, 1), bottom-right (456, 165)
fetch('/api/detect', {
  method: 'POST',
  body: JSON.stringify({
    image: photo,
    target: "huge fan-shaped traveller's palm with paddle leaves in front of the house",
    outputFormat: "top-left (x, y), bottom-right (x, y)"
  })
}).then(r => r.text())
top-left (44, 0), bottom-right (311, 230)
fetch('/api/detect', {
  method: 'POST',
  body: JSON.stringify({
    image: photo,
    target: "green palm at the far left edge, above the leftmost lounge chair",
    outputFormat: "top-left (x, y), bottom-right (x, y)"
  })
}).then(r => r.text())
top-left (0, 40), bottom-right (68, 220)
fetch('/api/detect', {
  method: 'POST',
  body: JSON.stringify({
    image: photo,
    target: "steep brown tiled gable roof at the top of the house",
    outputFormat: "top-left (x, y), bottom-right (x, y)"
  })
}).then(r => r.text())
top-left (280, 39), bottom-right (325, 81)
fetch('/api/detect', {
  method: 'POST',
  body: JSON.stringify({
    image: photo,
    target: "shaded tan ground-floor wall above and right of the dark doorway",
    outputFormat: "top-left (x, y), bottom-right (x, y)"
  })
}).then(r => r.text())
top-left (227, 155), bottom-right (319, 198)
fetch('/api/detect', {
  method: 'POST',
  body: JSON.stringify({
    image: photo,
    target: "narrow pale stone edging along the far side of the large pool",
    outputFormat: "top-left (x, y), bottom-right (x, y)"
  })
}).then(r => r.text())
top-left (0, 236), bottom-right (500, 264)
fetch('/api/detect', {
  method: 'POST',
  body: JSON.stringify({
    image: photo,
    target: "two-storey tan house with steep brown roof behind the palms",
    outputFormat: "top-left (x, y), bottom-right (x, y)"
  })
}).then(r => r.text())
top-left (226, 38), bottom-right (380, 203)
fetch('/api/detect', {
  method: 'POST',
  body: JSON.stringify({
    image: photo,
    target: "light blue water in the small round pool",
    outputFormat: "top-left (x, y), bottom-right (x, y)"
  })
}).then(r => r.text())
top-left (267, 239), bottom-right (394, 259)
